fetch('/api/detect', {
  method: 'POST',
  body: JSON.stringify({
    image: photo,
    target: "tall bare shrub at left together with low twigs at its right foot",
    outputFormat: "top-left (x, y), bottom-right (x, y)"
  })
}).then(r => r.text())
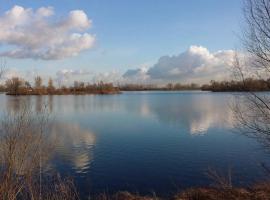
top-left (0, 104), bottom-right (78, 200)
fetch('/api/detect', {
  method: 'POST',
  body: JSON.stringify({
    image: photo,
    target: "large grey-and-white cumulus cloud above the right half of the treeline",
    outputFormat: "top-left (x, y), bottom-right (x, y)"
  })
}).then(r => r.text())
top-left (123, 46), bottom-right (234, 83)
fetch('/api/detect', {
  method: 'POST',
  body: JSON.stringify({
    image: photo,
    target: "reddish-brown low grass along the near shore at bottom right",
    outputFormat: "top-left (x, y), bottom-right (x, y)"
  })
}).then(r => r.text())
top-left (97, 169), bottom-right (270, 200)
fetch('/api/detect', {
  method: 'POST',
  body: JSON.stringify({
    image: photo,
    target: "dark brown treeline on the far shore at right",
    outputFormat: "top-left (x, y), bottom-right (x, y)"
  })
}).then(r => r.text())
top-left (201, 78), bottom-right (270, 92)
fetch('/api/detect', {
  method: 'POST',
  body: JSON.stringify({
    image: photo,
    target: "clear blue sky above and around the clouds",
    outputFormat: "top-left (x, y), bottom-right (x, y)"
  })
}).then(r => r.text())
top-left (0, 0), bottom-right (242, 83)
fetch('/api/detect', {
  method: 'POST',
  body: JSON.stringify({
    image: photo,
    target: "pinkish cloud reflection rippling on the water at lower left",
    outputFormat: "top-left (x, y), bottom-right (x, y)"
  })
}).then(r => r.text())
top-left (49, 122), bottom-right (96, 172)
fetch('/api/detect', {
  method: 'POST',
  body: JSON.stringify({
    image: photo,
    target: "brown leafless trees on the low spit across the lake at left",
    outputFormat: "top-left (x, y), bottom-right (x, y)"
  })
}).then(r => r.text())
top-left (0, 76), bottom-right (120, 95)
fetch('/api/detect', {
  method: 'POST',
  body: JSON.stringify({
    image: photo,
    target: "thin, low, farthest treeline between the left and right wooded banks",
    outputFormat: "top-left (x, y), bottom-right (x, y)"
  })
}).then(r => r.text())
top-left (118, 83), bottom-right (200, 91)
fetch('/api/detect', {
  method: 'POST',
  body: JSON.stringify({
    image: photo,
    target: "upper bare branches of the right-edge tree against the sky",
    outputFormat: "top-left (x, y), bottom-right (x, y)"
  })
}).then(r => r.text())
top-left (243, 0), bottom-right (270, 77)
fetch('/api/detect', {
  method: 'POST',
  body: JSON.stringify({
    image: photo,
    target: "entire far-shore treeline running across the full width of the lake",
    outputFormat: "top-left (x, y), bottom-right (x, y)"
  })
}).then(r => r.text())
top-left (0, 76), bottom-right (270, 95)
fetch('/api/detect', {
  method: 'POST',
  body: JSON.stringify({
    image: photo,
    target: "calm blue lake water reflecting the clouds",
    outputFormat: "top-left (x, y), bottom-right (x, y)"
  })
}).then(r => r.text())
top-left (0, 91), bottom-right (270, 196)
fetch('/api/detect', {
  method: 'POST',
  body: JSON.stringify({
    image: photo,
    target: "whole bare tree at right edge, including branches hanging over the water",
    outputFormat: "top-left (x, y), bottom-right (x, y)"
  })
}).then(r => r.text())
top-left (227, 3), bottom-right (270, 175)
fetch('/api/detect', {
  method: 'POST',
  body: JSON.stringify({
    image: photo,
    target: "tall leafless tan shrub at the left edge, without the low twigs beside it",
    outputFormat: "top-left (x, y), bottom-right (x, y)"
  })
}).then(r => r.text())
top-left (0, 106), bottom-right (49, 199)
